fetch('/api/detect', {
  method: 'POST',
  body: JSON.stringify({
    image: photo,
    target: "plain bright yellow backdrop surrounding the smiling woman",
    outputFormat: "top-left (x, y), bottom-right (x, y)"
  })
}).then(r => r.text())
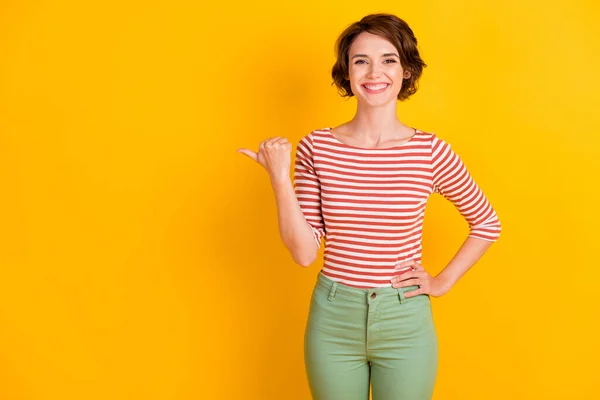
top-left (0, 0), bottom-right (600, 400)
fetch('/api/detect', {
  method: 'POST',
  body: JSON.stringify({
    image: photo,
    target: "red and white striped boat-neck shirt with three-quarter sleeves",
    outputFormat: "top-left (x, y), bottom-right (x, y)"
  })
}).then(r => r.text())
top-left (294, 128), bottom-right (501, 288)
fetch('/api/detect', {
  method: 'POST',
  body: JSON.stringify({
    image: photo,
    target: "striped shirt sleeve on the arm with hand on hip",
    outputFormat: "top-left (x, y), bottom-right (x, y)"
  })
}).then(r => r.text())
top-left (432, 135), bottom-right (502, 242)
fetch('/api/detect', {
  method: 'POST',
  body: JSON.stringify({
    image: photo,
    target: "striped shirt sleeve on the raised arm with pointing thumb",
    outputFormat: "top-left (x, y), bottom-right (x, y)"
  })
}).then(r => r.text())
top-left (294, 133), bottom-right (325, 248)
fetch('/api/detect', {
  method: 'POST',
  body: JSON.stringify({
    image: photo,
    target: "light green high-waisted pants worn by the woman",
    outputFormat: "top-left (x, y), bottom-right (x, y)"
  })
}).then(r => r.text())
top-left (304, 272), bottom-right (438, 400)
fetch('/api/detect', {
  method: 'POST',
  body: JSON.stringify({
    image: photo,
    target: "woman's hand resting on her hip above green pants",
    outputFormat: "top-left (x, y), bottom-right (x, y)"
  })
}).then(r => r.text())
top-left (392, 260), bottom-right (450, 297)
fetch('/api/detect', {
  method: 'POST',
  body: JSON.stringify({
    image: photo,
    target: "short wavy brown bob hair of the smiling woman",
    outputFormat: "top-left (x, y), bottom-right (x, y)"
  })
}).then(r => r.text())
top-left (331, 14), bottom-right (427, 100)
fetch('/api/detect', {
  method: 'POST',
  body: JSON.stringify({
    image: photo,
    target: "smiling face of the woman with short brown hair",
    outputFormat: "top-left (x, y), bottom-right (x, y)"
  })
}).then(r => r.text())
top-left (348, 32), bottom-right (410, 107)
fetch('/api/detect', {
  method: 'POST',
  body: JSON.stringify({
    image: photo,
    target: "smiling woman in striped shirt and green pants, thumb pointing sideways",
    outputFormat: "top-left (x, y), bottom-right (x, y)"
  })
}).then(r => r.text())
top-left (238, 14), bottom-right (501, 400)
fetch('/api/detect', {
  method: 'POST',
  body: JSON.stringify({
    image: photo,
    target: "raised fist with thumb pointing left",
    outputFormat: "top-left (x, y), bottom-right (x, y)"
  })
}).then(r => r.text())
top-left (237, 136), bottom-right (292, 182)
